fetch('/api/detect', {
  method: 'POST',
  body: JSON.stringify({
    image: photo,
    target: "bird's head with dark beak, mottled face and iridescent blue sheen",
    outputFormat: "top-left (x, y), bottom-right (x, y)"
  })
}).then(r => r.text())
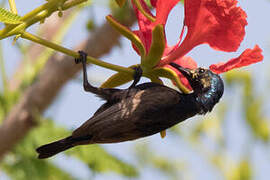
top-left (170, 63), bottom-right (224, 96)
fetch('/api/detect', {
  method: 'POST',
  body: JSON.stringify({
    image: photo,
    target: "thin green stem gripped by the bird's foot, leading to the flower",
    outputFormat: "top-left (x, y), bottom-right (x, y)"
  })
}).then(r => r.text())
top-left (21, 32), bottom-right (134, 74)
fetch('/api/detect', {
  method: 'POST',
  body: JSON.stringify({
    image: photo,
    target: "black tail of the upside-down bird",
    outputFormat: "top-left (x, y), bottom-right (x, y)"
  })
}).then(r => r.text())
top-left (36, 136), bottom-right (74, 159)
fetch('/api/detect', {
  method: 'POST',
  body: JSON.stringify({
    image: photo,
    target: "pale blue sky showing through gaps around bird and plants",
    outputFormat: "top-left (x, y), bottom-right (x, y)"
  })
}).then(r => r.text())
top-left (0, 0), bottom-right (270, 180)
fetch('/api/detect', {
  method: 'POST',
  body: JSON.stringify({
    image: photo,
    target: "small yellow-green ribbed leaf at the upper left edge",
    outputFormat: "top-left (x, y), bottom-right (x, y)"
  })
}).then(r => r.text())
top-left (0, 8), bottom-right (22, 24)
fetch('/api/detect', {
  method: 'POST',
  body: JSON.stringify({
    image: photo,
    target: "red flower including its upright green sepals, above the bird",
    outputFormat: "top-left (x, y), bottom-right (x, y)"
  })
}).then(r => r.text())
top-left (107, 0), bottom-right (263, 87)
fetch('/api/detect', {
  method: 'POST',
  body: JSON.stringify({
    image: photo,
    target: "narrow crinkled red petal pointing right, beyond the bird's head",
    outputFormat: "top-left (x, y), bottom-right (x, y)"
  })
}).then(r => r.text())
top-left (209, 45), bottom-right (263, 74)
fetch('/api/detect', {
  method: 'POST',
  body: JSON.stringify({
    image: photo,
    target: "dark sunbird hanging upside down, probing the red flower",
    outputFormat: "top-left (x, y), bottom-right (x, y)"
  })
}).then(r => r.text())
top-left (36, 51), bottom-right (224, 159)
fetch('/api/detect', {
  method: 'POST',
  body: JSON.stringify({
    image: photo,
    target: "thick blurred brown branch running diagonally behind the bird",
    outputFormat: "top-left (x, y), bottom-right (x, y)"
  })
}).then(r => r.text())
top-left (0, 7), bottom-right (135, 159)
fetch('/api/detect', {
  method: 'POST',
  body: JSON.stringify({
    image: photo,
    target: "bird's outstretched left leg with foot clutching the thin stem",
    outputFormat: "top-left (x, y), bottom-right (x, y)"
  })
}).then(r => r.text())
top-left (75, 51), bottom-right (119, 101)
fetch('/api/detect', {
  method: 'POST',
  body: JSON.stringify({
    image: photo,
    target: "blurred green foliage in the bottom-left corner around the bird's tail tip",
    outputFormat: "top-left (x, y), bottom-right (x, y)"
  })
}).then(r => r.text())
top-left (2, 120), bottom-right (73, 180)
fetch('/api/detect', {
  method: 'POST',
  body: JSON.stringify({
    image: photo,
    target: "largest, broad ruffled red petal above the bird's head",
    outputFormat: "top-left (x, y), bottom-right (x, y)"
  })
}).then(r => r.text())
top-left (162, 0), bottom-right (247, 64)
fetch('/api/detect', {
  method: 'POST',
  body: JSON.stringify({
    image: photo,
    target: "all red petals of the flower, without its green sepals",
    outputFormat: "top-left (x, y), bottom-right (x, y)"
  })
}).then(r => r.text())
top-left (130, 0), bottom-right (263, 88)
